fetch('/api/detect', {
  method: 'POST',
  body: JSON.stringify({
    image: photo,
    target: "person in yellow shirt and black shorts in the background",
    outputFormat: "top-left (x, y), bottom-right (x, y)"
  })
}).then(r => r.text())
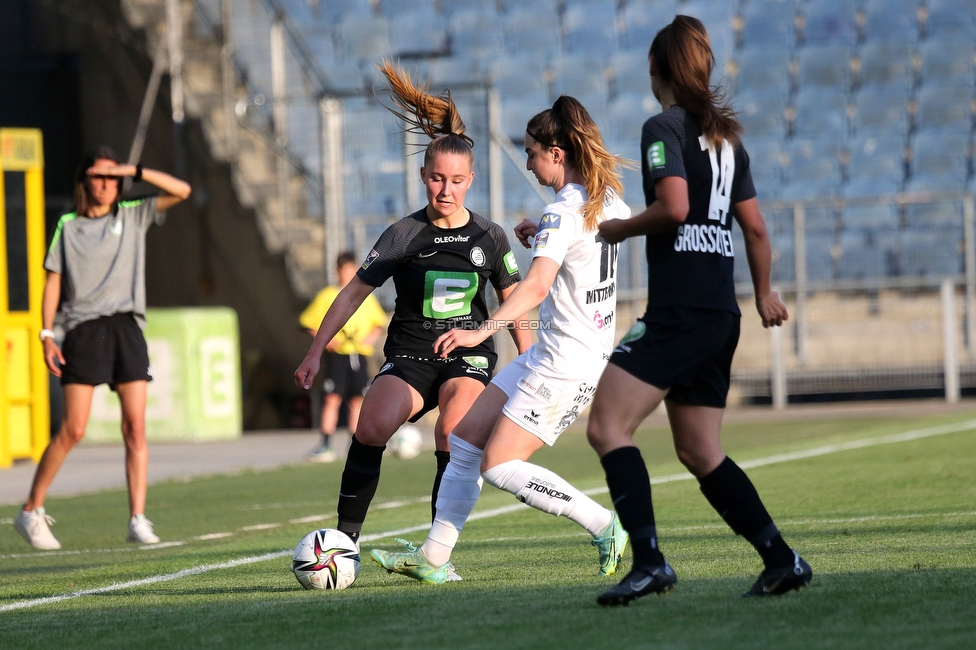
top-left (298, 251), bottom-right (386, 463)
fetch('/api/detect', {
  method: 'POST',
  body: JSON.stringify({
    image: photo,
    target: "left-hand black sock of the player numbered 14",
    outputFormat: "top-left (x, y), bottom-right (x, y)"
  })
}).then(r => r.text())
top-left (600, 447), bottom-right (664, 566)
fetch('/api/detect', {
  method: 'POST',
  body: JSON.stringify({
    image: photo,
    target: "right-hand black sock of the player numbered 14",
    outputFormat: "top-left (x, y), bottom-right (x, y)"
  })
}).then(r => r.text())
top-left (698, 456), bottom-right (793, 568)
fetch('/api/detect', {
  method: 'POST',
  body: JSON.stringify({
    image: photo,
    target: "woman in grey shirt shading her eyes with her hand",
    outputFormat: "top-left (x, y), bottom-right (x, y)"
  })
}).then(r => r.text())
top-left (14, 147), bottom-right (190, 550)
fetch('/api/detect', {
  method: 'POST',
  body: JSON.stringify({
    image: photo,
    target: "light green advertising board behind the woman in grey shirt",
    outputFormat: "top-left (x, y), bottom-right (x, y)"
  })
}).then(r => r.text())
top-left (85, 307), bottom-right (241, 442)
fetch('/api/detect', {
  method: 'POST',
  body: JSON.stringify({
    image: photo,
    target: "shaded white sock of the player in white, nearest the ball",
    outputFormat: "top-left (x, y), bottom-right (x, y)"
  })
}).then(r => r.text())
top-left (420, 433), bottom-right (485, 566)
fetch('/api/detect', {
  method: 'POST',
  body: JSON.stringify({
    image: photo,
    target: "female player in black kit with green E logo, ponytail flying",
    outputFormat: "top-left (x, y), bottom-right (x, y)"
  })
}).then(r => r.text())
top-left (295, 62), bottom-right (531, 556)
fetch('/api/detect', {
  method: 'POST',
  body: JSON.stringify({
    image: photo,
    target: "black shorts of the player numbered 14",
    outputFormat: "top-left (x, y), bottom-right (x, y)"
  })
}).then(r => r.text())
top-left (610, 307), bottom-right (740, 408)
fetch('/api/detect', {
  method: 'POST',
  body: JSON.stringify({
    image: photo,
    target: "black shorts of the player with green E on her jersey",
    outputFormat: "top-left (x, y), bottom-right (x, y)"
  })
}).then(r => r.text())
top-left (376, 353), bottom-right (498, 422)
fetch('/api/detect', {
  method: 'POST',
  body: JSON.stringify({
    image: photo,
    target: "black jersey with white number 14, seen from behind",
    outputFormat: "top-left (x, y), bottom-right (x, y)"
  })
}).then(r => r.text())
top-left (641, 106), bottom-right (756, 314)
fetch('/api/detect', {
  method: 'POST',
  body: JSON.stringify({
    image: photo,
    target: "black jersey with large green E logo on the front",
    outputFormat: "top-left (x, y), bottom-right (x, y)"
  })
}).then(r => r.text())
top-left (357, 209), bottom-right (520, 357)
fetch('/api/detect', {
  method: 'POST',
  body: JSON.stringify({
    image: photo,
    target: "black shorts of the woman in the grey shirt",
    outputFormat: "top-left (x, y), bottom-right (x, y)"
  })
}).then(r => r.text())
top-left (61, 313), bottom-right (152, 390)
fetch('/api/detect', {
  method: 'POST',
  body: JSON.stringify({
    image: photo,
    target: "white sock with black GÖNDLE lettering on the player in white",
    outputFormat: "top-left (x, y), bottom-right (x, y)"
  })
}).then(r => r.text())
top-left (484, 456), bottom-right (613, 537)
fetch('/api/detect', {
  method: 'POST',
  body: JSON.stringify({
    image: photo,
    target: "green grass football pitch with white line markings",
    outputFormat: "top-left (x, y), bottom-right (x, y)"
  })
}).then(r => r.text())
top-left (0, 412), bottom-right (976, 650)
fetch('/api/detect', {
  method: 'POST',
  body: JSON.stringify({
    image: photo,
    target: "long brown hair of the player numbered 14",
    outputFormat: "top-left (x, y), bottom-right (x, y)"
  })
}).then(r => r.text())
top-left (649, 16), bottom-right (743, 146)
